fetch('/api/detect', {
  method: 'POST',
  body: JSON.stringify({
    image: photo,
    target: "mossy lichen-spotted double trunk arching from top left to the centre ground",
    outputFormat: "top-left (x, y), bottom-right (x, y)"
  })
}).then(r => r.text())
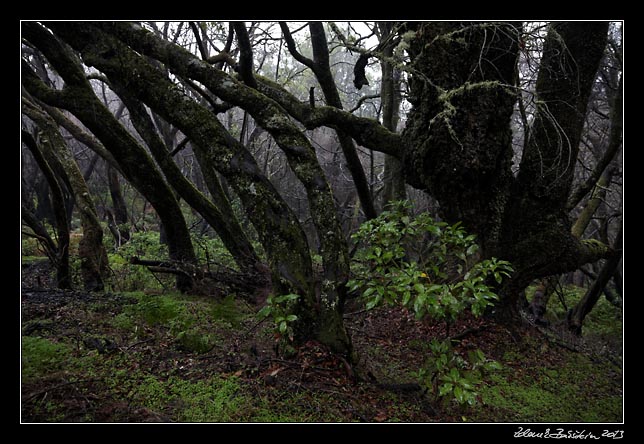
top-left (34, 23), bottom-right (351, 353)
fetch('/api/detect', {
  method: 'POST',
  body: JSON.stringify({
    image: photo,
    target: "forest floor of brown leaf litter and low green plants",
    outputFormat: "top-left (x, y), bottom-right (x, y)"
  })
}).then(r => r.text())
top-left (21, 256), bottom-right (623, 423)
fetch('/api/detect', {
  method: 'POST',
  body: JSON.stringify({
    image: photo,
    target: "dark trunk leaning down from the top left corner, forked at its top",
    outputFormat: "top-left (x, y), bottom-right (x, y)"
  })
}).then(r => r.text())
top-left (22, 22), bottom-right (196, 291)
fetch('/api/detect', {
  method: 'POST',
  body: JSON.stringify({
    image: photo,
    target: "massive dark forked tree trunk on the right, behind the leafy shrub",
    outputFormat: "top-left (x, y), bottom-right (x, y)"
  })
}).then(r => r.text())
top-left (403, 22), bottom-right (612, 320)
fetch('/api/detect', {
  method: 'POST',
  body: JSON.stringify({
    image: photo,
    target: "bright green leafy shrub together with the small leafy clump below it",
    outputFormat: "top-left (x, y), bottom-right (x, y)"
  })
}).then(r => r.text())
top-left (347, 202), bottom-right (512, 405)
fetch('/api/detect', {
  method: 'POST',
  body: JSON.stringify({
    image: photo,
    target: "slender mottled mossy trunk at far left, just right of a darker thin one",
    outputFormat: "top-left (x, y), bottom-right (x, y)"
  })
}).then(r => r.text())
top-left (22, 100), bottom-right (108, 291)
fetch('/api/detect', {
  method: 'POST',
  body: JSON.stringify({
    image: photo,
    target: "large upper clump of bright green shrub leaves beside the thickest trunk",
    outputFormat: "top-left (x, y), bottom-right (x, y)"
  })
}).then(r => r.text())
top-left (348, 202), bottom-right (512, 321)
